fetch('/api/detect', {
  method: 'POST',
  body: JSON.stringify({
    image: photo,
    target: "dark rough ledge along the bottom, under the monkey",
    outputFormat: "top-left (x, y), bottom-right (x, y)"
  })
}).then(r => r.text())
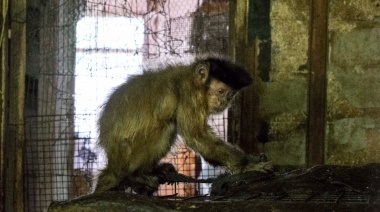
top-left (48, 163), bottom-right (380, 212)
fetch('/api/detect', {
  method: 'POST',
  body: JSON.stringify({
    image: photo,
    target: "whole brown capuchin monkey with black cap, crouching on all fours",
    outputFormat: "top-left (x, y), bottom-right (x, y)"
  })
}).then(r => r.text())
top-left (95, 56), bottom-right (272, 195)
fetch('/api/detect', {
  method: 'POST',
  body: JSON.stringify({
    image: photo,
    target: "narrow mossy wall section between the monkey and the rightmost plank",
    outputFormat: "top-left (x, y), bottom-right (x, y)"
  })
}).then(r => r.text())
top-left (258, 0), bottom-right (310, 166)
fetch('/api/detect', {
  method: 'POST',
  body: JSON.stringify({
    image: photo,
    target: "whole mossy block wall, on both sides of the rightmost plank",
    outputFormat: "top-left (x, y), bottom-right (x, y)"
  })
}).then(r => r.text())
top-left (257, 0), bottom-right (380, 166)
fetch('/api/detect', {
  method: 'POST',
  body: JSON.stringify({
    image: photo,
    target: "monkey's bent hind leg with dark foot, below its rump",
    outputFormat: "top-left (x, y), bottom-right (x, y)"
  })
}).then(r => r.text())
top-left (95, 123), bottom-right (176, 195)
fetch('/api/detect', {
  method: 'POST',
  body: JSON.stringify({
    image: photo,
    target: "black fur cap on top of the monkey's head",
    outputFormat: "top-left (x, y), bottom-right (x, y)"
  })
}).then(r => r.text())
top-left (203, 57), bottom-right (253, 90)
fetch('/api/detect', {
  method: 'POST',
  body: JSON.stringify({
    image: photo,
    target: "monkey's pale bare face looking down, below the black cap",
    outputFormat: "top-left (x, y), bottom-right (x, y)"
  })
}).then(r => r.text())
top-left (207, 78), bottom-right (236, 114)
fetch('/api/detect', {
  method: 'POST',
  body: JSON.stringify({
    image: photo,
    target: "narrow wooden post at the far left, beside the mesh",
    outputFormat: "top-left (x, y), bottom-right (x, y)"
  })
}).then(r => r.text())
top-left (4, 0), bottom-right (26, 212)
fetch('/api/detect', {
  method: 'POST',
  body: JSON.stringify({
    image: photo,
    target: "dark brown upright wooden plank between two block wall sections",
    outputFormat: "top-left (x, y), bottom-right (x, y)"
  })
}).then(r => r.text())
top-left (306, 0), bottom-right (328, 166)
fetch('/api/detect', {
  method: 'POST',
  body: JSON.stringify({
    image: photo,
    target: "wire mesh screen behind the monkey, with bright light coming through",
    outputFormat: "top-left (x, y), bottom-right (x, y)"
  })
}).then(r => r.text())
top-left (25, 0), bottom-right (232, 211)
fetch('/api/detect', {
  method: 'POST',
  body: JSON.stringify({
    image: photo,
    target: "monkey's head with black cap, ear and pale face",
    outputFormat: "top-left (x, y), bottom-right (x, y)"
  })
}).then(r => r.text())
top-left (195, 57), bottom-right (253, 113)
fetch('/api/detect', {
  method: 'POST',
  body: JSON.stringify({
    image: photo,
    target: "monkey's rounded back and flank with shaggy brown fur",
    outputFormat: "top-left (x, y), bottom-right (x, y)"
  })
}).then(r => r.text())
top-left (98, 67), bottom-right (191, 158)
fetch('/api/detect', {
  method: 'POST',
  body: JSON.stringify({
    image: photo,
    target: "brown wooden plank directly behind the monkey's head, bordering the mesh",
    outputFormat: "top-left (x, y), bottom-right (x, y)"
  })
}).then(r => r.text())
top-left (228, 0), bottom-right (256, 153)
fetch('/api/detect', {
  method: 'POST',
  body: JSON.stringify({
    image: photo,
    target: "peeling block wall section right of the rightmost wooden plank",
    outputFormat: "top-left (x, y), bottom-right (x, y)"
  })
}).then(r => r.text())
top-left (325, 0), bottom-right (380, 165)
